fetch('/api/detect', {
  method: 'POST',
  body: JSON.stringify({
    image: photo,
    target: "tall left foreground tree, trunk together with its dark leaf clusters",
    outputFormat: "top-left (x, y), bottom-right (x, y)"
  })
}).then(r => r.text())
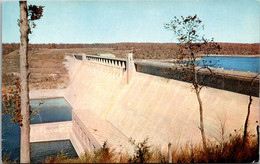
top-left (17, 1), bottom-right (43, 163)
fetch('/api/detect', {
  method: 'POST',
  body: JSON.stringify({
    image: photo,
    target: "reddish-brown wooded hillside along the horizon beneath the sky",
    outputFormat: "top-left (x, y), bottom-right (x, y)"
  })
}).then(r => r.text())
top-left (2, 43), bottom-right (260, 59)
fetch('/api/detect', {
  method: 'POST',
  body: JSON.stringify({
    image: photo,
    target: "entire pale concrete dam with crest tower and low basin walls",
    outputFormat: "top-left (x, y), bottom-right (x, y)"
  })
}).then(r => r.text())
top-left (30, 54), bottom-right (259, 156)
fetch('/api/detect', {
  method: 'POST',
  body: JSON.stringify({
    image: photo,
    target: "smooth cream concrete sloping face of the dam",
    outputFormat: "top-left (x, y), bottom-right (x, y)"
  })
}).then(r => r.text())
top-left (64, 55), bottom-right (259, 152)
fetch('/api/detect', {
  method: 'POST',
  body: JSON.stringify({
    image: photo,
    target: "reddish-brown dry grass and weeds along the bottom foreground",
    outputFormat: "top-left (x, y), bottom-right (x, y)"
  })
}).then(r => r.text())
top-left (41, 133), bottom-right (259, 163)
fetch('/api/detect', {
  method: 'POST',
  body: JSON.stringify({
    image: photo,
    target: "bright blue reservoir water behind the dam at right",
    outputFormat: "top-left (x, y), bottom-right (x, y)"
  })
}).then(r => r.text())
top-left (199, 56), bottom-right (260, 73)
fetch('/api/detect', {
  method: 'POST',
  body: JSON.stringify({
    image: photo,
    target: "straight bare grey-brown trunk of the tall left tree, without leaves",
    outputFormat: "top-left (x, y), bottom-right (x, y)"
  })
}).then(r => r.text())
top-left (19, 1), bottom-right (30, 163)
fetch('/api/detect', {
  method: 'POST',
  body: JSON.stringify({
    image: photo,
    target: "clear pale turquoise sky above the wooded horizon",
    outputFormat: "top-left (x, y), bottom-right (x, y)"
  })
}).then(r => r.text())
top-left (2, 0), bottom-right (260, 43)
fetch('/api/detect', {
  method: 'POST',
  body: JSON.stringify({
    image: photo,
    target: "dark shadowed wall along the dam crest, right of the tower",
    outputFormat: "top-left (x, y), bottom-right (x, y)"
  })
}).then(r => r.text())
top-left (135, 61), bottom-right (259, 97)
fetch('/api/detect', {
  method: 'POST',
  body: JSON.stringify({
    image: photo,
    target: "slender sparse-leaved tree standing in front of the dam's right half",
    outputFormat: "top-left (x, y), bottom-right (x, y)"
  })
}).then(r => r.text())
top-left (164, 15), bottom-right (220, 150)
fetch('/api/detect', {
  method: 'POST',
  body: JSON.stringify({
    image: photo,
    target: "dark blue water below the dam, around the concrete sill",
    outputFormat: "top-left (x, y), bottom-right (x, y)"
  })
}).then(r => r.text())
top-left (2, 98), bottom-right (77, 162)
